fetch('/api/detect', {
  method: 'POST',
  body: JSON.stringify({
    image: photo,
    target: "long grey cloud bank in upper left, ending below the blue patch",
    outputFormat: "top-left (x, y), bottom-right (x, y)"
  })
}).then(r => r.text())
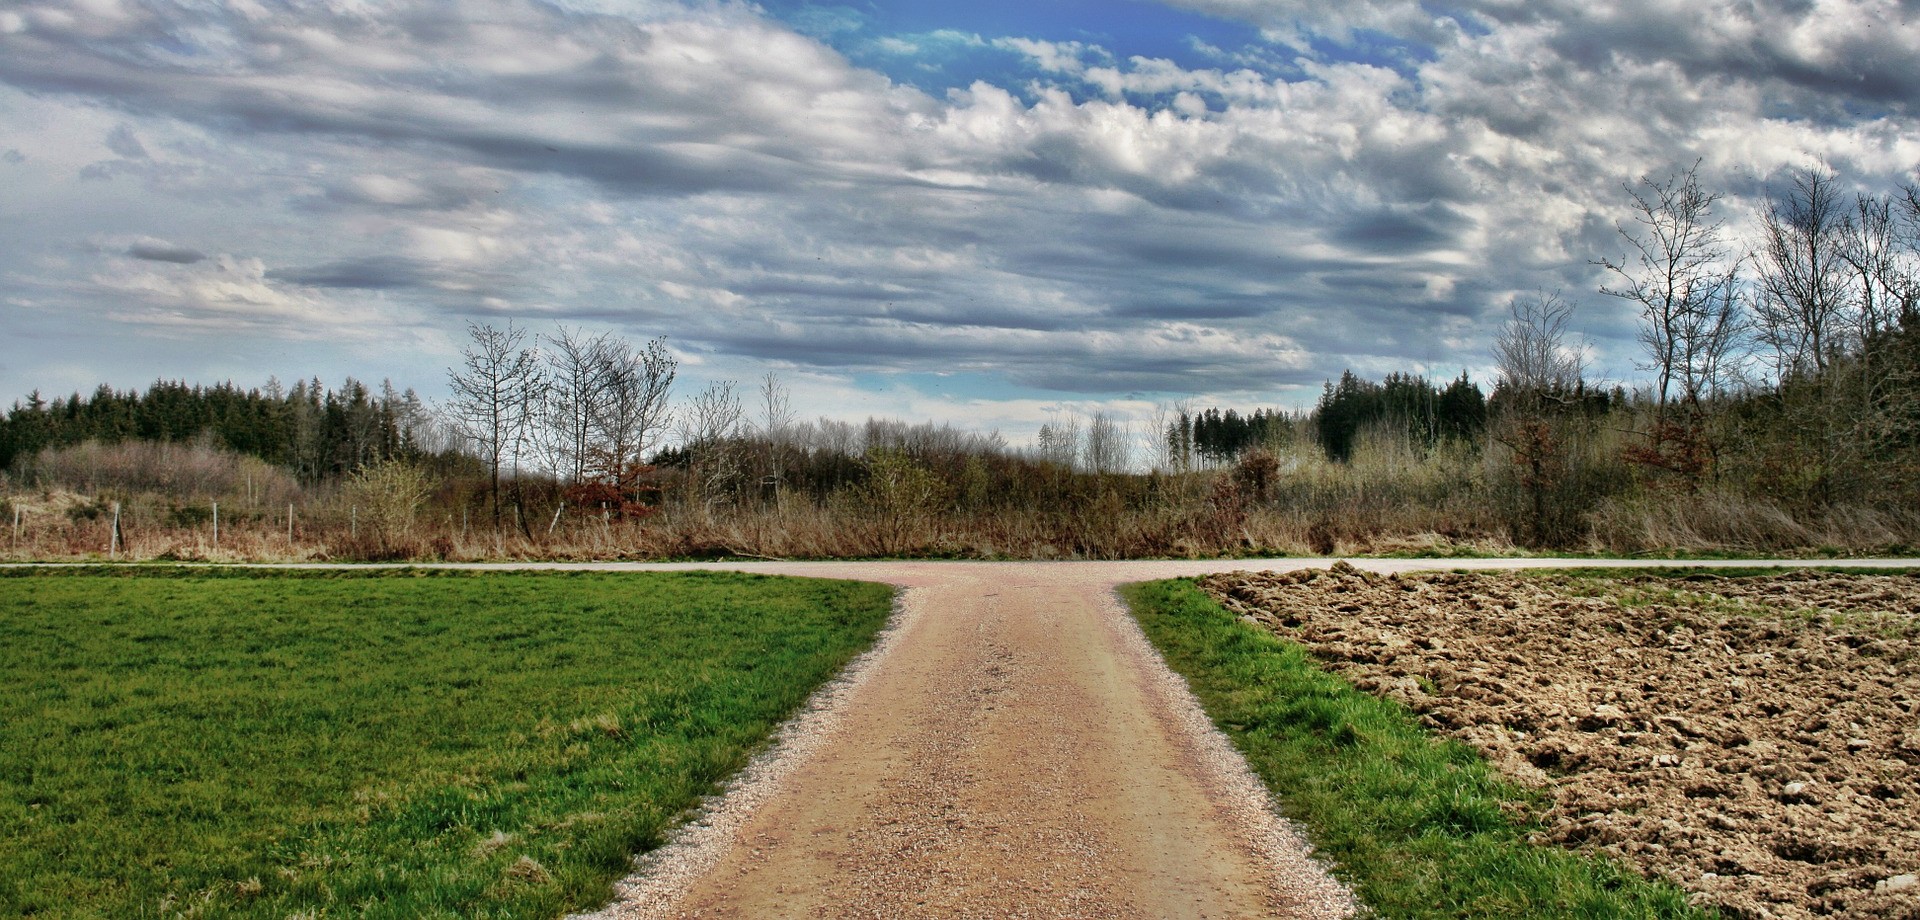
top-left (0, 2), bottom-right (921, 196)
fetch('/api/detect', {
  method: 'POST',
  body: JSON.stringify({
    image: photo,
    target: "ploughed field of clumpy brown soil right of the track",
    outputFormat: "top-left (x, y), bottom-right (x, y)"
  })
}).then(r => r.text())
top-left (1202, 565), bottom-right (1920, 918)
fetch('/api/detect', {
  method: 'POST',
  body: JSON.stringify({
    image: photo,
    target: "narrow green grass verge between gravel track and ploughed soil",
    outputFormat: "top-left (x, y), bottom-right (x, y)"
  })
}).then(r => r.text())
top-left (1125, 580), bottom-right (1713, 918)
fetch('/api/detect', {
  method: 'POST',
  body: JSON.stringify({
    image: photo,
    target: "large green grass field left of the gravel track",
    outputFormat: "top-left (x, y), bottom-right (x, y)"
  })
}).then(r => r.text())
top-left (0, 570), bottom-right (891, 918)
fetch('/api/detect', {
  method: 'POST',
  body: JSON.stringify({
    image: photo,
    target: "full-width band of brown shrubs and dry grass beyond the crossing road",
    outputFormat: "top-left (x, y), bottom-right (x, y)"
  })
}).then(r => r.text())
top-left (0, 407), bottom-right (1920, 563)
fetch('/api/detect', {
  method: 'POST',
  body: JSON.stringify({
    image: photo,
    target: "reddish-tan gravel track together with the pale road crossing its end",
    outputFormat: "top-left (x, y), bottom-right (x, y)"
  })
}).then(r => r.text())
top-left (22, 559), bottom-right (1920, 920)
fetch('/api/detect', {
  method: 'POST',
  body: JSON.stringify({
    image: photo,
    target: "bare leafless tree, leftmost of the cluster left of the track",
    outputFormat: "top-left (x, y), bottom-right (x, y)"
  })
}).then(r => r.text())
top-left (447, 323), bottom-right (545, 526)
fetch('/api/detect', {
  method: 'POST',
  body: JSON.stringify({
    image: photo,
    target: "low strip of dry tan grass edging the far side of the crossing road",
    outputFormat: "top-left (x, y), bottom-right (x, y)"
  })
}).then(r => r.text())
top-left (0, 482), bottom-right (1920, 563)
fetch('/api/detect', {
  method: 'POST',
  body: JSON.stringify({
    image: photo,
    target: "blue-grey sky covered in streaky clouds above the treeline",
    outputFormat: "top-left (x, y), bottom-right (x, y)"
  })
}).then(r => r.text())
top-left (0, 0), bottom-right (1920, 440)
